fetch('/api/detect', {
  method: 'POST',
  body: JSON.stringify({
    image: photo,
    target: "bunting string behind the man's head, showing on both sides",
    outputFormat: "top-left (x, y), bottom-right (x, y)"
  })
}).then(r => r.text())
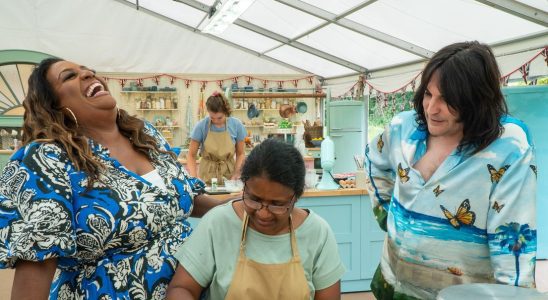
top-left (334, 46), bottom-right (548, 99)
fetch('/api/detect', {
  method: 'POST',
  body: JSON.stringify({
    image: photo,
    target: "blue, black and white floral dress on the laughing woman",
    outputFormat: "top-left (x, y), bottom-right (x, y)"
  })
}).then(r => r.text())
top-left (0, 124), bottom-right (203, 299)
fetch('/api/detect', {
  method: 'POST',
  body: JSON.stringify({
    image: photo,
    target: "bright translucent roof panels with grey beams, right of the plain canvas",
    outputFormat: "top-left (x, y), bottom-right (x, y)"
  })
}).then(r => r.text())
top-left (128, 0), bottom-right (548, 77)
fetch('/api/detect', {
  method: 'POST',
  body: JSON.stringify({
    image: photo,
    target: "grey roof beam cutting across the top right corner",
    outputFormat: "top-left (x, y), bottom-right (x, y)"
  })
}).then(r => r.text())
top-left (476, 0), bottom-right (548, 27)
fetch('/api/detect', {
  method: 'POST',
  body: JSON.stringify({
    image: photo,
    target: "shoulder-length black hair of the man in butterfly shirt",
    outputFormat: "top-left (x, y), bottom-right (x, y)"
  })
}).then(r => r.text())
top-left (413, 41), bottom-right (508, 153)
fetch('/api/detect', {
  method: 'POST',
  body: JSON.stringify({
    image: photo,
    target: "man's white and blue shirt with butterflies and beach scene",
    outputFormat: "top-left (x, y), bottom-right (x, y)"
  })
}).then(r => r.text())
top-left (366, 112), bottom-right (537, 299)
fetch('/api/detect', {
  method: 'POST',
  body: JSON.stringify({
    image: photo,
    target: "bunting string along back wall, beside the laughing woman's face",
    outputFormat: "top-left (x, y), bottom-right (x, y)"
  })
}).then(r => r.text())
top-left (103, 74), bottom-right (314, 89)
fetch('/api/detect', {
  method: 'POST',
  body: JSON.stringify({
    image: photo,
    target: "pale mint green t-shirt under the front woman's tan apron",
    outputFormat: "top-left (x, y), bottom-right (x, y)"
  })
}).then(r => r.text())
top-left (175, 202), bottom-right (345, 299)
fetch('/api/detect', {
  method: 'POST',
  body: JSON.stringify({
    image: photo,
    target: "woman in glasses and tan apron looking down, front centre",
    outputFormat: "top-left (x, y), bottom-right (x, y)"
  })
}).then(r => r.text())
top-left (168, 139), bottom-right (345, 300)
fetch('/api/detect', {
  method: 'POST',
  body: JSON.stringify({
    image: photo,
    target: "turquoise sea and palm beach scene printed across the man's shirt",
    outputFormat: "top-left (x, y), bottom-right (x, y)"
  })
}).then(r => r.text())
top-left (389, 198), bottom-right (536, 281)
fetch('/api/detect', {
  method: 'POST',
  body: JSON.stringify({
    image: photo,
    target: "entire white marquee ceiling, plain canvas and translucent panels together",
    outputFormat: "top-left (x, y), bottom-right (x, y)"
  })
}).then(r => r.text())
top-left (0, 0), bottom-right (548, 78)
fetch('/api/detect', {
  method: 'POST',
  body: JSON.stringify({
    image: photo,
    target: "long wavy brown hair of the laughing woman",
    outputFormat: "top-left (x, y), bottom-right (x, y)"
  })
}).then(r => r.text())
top-left (23, 58), bottom-right (173, 187)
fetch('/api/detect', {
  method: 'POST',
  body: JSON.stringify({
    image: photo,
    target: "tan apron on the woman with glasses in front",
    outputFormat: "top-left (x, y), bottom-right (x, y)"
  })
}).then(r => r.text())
top-left (225, 211), bottom-right (310, 300)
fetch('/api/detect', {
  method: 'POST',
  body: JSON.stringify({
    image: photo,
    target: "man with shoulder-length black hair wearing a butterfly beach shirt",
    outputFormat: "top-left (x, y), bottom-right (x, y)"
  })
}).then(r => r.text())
top-left (366, 42), bottom-right (537, 299)
